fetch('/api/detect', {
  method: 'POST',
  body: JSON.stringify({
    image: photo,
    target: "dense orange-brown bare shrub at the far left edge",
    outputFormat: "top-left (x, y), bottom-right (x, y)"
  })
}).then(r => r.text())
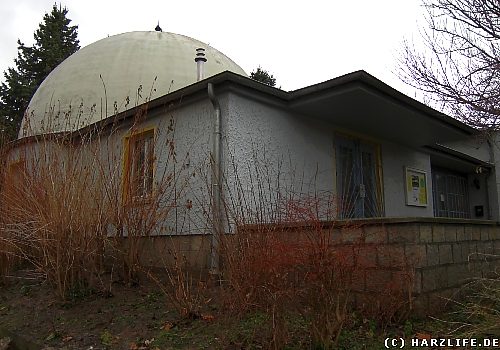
top-left (1, 136), bottom-right (109, 298)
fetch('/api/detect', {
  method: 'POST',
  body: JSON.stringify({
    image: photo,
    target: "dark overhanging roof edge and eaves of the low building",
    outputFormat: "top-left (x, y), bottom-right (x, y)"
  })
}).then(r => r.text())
top-left (14, 70), bottom-right (478, 149)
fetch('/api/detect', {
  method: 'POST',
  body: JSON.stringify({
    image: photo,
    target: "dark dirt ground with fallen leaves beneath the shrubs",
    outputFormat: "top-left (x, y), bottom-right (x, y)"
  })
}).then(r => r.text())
top-left (0, 270), bottom-right (454, 350)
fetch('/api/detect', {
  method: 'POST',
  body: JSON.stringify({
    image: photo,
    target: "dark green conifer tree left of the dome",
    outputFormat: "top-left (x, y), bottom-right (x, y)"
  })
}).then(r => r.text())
top-left (0, 4), bottom-right (80, 144)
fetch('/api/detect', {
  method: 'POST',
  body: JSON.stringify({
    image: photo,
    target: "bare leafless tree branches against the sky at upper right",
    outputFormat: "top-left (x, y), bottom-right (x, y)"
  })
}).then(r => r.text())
top-left (399, 0), bottom-right (500, 129)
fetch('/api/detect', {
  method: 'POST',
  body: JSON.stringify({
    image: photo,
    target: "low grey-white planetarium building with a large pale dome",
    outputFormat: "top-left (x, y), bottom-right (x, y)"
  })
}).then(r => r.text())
top-left (6, 31), bottom-right (500, 290)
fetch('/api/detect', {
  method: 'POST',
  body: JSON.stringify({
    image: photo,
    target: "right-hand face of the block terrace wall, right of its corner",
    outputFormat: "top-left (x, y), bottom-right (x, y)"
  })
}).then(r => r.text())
top-left (410, 219), bottom-right (500, 313)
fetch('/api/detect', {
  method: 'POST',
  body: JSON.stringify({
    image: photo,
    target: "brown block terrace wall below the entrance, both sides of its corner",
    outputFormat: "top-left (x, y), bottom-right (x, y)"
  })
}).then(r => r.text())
top-left (332, 218), bottom-right (500, 315)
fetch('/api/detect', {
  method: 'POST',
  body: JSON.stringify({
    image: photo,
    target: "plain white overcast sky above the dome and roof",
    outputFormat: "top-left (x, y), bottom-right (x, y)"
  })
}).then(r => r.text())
top-left (0, 0), bottom-right (423, 97)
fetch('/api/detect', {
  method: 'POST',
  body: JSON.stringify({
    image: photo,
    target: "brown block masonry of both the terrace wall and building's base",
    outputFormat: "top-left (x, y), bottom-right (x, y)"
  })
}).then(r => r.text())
top-left (131, 218), bottom-right (500, 315)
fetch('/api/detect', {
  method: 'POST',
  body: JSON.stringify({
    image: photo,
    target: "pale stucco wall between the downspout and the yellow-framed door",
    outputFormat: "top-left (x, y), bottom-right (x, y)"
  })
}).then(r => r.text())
top-left (222, 92), bottom-right (334, 224)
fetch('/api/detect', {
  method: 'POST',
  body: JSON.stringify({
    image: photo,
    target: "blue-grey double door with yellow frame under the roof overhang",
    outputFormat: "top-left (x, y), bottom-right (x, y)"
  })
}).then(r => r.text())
top-left (335, 136), bottom-right (382, 219)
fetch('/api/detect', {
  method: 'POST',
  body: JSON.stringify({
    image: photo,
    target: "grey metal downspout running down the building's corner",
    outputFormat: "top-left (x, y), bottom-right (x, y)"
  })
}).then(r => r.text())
top-left (208, 83), bottom-right (223, 274)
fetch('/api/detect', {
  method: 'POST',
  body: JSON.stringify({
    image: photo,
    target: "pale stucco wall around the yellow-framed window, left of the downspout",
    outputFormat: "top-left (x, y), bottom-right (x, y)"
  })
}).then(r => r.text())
top-left (93, 99), bottom-right (213, 234)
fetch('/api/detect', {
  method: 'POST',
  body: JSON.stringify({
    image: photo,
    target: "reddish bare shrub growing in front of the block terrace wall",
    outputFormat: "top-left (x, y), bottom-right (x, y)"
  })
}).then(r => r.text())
top-left (213, 148), bottom-right (420, 349)
